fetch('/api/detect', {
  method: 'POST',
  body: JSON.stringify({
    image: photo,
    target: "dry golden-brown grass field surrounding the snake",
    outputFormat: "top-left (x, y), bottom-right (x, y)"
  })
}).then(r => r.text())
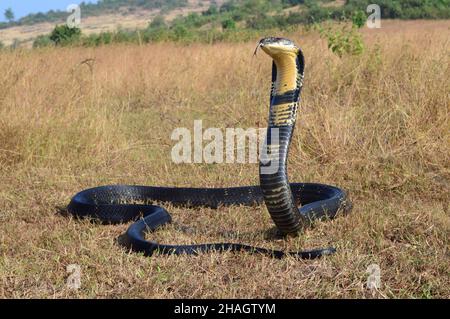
top-left (0, 21), bottom-right (450, 298)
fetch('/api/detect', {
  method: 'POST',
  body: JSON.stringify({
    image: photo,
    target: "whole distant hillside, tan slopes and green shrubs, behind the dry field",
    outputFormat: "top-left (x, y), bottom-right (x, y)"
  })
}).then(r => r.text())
top-left (0, 0), bottom-right (450, 47)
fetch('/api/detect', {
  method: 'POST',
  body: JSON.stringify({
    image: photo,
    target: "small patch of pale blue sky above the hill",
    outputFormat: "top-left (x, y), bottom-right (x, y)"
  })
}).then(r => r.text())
top-left (0, 0), bottom-right (97, 21)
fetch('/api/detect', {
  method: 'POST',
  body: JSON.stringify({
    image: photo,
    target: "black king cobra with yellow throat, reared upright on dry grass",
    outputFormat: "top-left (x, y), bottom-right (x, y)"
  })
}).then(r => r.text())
top-left (67, 37), bottom-right (351, 259)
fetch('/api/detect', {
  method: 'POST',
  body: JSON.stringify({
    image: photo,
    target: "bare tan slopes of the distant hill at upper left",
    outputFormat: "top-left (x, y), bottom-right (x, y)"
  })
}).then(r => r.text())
top-left (0, 0), bottom-right (218, 47)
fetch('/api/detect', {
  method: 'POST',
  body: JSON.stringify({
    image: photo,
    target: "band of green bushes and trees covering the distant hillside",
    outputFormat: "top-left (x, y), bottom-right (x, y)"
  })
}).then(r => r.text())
top-left (1, 0), bottom-right (450, 47)
